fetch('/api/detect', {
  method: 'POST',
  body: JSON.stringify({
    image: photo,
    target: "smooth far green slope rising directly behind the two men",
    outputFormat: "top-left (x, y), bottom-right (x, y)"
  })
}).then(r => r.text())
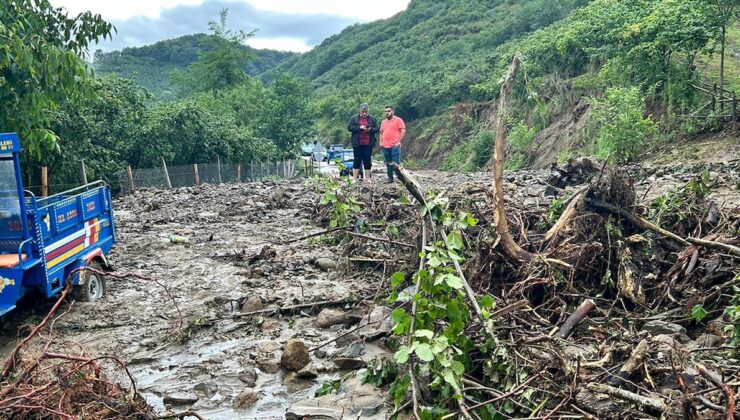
top-left (277, 0), bottom-right (587, 140)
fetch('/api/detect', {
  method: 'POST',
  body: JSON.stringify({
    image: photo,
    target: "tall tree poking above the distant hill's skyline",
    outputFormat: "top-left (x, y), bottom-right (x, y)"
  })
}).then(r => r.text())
top-left (172, 8), bottom-right (255, 96)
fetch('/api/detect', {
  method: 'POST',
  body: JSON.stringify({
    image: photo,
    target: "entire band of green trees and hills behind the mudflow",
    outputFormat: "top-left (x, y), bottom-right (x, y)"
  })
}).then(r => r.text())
top-left (0, 0), bottom-right (740, 192)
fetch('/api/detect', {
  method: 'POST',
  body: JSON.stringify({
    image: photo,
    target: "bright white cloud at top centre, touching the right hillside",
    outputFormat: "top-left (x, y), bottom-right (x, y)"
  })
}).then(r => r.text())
top-left (244, 0), bottom-right (409, 21)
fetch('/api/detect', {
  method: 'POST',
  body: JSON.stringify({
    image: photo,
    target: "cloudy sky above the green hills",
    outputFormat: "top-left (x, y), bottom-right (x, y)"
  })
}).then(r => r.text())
top-left (51, 0), bottom-right (409, 52)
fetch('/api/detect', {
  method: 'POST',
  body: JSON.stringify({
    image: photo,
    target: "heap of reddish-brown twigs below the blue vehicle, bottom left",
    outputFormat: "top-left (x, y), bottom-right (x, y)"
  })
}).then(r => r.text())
top-left (0, 283), bottom-right (157, 419)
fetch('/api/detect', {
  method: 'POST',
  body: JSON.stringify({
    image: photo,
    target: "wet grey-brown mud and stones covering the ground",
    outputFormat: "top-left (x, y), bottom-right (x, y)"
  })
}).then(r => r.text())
top-left (1, 161), bottom-right (740, 419)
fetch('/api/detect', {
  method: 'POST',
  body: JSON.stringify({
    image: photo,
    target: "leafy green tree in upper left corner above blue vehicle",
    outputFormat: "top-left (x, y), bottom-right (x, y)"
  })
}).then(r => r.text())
top-left (0, 0), bottom-right (113, 157)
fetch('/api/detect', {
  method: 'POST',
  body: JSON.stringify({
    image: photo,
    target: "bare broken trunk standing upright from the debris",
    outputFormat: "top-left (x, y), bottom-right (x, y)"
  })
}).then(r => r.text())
top-left (493, 54), bottom-right (532, 261)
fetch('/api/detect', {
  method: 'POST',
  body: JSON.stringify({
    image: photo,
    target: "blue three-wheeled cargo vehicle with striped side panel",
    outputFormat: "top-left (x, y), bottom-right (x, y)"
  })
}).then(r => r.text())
top-left (0, 133), bottom-right (116, 316)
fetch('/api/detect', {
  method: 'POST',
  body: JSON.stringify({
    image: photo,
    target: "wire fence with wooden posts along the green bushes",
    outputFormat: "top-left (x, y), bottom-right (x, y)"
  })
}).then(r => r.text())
top-left (116, 159), bottom-right (310, 194)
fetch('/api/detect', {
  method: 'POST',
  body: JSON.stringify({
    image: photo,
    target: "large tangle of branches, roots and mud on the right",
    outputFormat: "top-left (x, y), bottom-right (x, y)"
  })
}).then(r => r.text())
top-left (316, 160), bottom-right (740, 419)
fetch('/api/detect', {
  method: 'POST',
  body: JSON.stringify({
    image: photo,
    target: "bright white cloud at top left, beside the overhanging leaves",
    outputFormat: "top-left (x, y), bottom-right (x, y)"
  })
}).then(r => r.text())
top-left (51, 0), bottom-right (203, 20)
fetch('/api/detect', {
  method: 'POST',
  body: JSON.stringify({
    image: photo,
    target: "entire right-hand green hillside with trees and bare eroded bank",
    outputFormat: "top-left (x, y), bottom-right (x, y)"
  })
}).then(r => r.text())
top-left (278, 0), bottom-right (740, 170)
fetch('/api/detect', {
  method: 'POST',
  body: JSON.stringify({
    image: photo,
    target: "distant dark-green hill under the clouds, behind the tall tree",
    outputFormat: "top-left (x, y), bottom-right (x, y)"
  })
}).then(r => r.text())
top-left (93, 34), bottom-right (296, 99)
